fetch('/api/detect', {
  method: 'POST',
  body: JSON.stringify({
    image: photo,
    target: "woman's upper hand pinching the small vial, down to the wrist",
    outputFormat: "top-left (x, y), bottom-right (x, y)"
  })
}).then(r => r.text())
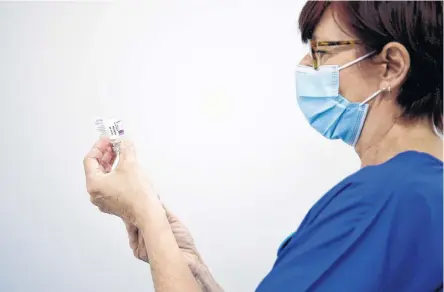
top-left (84, 138), bottom-right (164, 226)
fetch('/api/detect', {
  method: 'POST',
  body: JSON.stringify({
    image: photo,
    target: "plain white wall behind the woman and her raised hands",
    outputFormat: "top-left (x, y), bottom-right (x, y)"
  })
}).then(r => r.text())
top-left (0, 0), bottom-right (359, 292)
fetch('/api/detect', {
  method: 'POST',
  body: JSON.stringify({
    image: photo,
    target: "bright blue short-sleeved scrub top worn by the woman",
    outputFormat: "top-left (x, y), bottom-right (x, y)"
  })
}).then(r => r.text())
top-left (256, 151), bottom-right (443, 292)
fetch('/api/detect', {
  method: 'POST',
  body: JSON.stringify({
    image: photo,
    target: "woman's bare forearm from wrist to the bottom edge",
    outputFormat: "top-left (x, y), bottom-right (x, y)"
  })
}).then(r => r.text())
top-left (137, 200), bottom-right (202, 292)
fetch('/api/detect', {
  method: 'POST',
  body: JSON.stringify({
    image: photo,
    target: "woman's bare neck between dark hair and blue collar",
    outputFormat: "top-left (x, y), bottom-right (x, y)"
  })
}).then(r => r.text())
top-left (356, 121), bottom-right (443, 167)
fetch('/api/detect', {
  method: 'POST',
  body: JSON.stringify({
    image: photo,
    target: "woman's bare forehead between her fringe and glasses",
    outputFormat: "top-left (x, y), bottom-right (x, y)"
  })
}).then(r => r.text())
top-left (313, 7), bottom-right (354, 41)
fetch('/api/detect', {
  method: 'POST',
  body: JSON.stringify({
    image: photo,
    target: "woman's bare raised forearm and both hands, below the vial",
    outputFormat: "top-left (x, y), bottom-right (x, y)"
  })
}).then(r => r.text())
top-left (84, 138), bottom-right (222, 292)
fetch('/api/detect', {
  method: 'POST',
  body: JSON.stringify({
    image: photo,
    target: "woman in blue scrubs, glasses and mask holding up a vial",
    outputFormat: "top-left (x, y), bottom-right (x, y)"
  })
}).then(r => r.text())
top-left (84, 1), bottom-right (443, 292)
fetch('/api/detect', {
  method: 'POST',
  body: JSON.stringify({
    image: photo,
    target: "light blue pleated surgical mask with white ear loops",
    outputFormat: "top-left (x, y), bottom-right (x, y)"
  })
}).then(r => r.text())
top-left (296, 52), bottom-right (384, 147)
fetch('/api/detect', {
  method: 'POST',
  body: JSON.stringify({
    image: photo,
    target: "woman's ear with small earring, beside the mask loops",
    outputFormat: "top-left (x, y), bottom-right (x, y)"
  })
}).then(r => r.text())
top-left (378, 42), bottom-right (410, 90)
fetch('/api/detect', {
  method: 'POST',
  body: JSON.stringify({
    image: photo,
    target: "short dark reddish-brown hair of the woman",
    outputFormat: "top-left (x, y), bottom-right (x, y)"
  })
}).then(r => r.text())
top-left (299, 1), bottom-right (443, 129)
